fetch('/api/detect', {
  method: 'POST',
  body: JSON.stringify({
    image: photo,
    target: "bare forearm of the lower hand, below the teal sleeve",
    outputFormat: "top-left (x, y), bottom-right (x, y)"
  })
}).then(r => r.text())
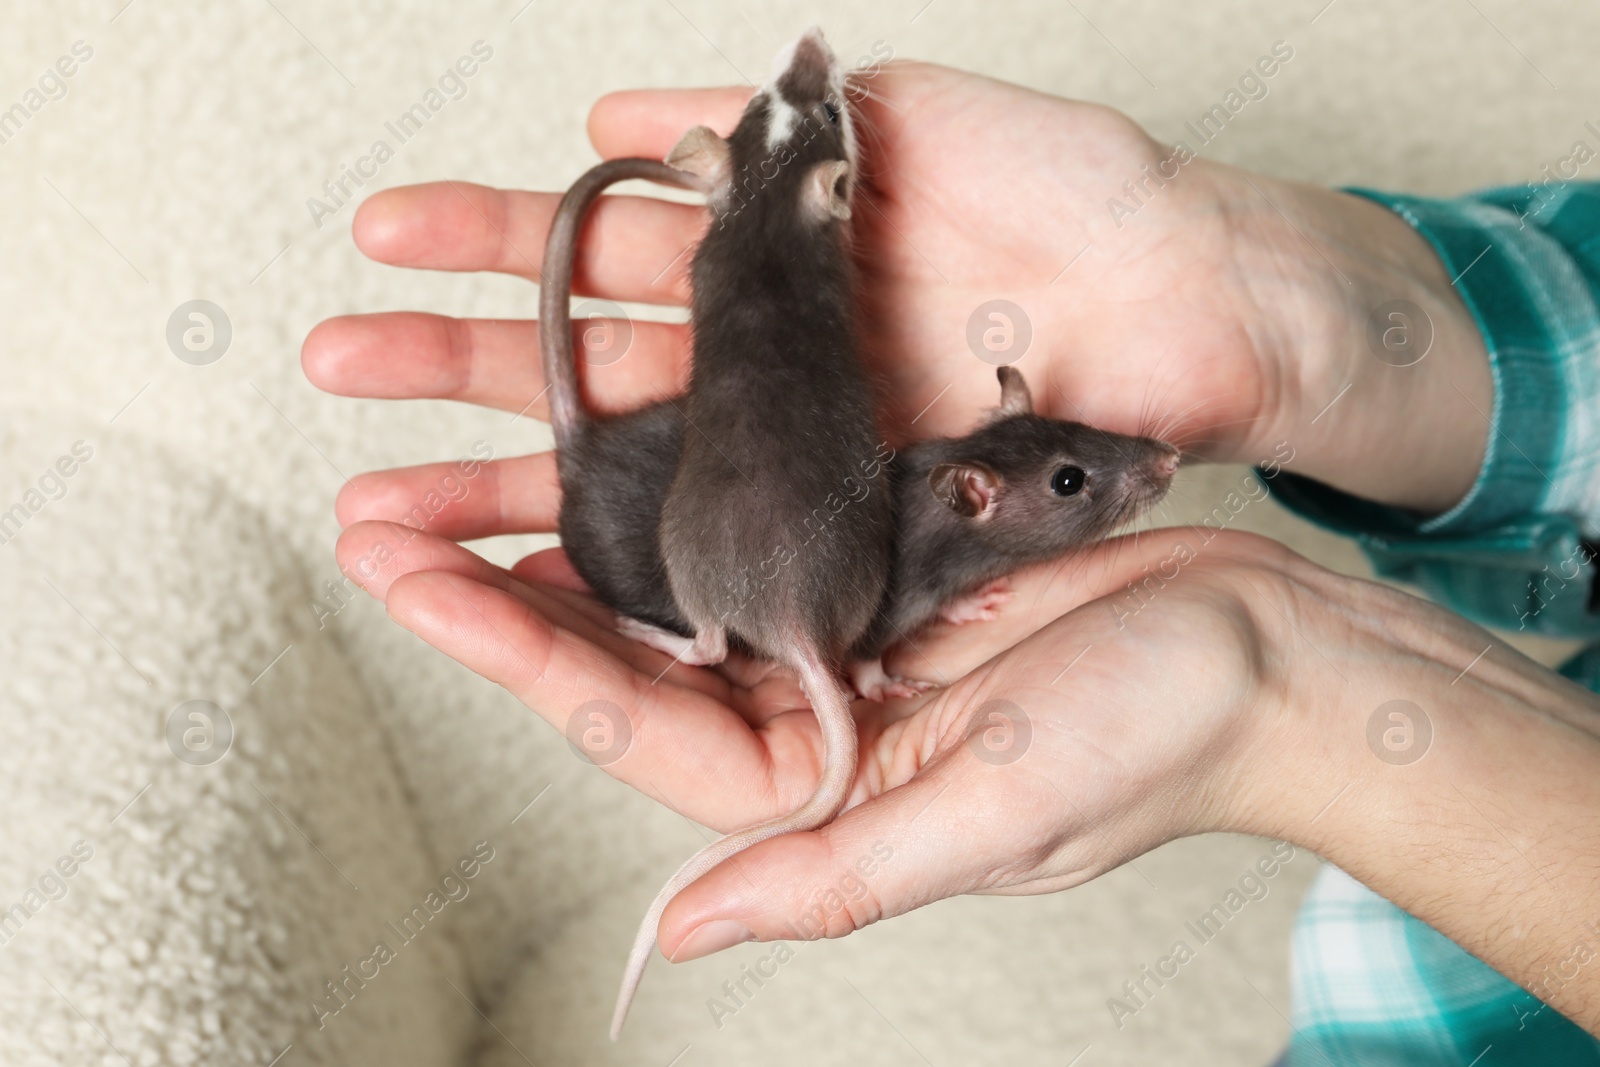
top-left (1245, 579), bottom-right (1600, 1030)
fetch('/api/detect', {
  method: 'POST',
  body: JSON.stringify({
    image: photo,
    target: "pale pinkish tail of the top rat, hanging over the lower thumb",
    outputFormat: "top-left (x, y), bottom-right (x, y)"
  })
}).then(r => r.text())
top-left (611, 649), bottom-right (856, 1041)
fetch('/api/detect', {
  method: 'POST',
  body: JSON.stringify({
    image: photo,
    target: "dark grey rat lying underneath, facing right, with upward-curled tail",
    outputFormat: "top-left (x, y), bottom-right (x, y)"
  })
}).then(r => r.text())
top-left (541, 167), bottom-right (1173, 675)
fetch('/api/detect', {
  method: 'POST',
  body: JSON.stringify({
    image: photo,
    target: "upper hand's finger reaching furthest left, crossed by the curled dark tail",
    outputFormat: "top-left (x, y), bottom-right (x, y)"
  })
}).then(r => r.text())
top-left (301, 312), bottom-right (690, 419)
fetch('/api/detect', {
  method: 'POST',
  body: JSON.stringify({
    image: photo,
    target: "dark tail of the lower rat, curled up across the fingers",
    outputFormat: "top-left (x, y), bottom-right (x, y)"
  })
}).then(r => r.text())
top-left (539, 158), bottom-right (706, 451)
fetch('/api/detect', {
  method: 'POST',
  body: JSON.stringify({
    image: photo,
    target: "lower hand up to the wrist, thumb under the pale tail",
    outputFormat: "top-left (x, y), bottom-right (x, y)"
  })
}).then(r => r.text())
top-left (339, 523), bottom-right (1309, 958)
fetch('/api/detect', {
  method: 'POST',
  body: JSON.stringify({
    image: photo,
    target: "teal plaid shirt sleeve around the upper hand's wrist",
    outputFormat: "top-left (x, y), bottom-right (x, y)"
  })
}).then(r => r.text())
top-left (1270, 182), bottom-right (1600, 637)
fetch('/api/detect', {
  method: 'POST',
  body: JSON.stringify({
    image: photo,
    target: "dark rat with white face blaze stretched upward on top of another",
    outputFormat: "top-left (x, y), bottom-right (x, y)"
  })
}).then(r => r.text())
top-left (611, 29), bottom-right (891, 1038)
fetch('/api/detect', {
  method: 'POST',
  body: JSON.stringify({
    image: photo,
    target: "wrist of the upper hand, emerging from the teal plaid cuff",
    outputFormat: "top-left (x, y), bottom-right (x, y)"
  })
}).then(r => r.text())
top-left (1227, 164), bottom-right (1494, 515)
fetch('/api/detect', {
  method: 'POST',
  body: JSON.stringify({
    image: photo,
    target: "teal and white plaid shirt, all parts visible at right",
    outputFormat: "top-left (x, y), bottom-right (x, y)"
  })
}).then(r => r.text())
top-left (1267, 179), bottom-right (1600, 1067)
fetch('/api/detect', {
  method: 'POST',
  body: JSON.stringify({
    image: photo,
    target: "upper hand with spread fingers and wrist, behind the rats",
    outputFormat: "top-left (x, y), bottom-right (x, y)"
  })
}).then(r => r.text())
top-left (302, 64), bottom-right (1491, 537)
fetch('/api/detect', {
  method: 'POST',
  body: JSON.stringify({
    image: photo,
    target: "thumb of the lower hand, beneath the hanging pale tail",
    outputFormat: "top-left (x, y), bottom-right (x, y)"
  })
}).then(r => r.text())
top-left (658, 745), bottom-right (989, 963)
